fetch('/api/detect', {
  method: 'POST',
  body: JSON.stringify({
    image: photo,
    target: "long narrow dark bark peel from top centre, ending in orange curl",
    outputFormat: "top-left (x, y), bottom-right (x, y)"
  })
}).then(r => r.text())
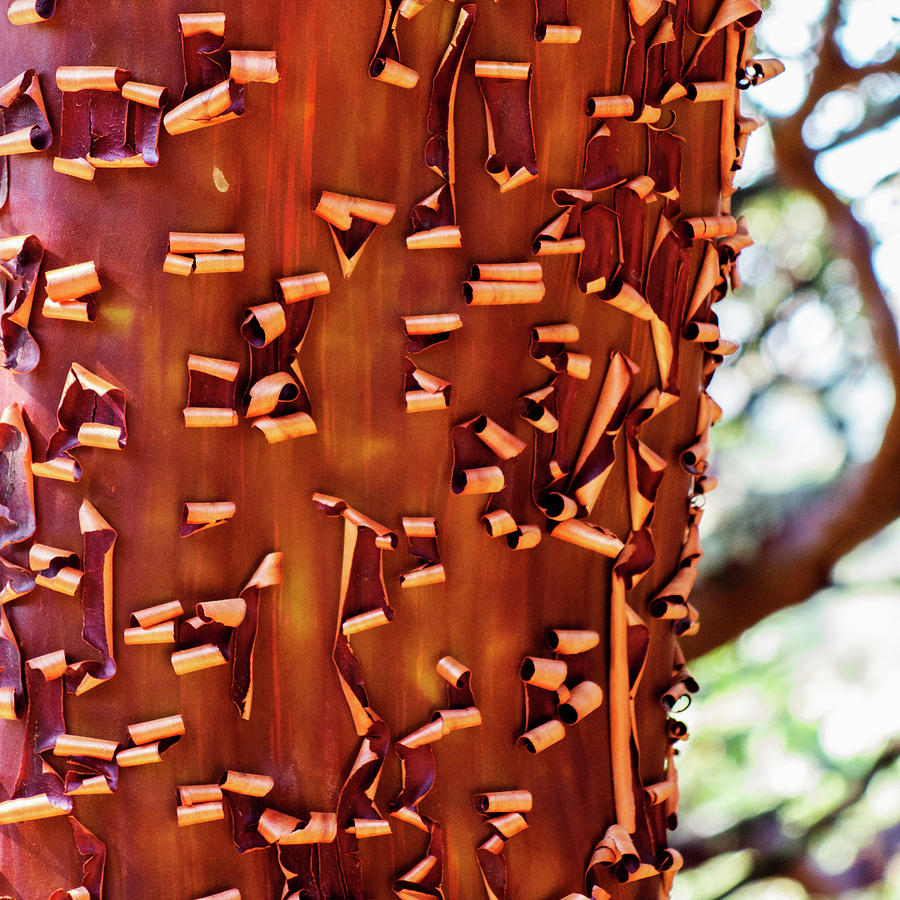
top-left (410, 3), bottom-right (476, 250)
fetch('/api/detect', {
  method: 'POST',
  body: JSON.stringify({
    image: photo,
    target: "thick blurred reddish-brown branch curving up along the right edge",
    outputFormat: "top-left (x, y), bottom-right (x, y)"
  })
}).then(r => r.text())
top-left (684, 8), bottom-right (900, 657)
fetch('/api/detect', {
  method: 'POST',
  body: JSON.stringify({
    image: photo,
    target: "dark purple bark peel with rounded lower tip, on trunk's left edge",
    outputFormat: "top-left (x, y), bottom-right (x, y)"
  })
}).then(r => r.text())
top-left (0, 236), bottom-right (44, 375)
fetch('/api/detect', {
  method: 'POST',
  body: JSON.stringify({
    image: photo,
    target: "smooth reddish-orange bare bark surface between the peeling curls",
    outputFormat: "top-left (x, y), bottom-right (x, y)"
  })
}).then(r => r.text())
top-left (0, 0), bottom-right (721, 900)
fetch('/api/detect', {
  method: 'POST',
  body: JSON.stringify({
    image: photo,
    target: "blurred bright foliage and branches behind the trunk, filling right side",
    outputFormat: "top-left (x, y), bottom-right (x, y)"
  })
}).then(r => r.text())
top-left (673, 0), bottom-right (900, 900)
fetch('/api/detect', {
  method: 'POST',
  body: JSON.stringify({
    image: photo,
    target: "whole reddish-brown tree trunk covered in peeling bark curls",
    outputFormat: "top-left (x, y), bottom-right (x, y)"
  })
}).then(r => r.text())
top-left (0, 0), bottom-right (763, 900)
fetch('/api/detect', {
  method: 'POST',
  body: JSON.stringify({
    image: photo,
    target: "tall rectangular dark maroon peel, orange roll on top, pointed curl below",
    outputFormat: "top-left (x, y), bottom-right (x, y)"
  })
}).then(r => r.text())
top-left (475, 60), bottom-right (537, 193)
